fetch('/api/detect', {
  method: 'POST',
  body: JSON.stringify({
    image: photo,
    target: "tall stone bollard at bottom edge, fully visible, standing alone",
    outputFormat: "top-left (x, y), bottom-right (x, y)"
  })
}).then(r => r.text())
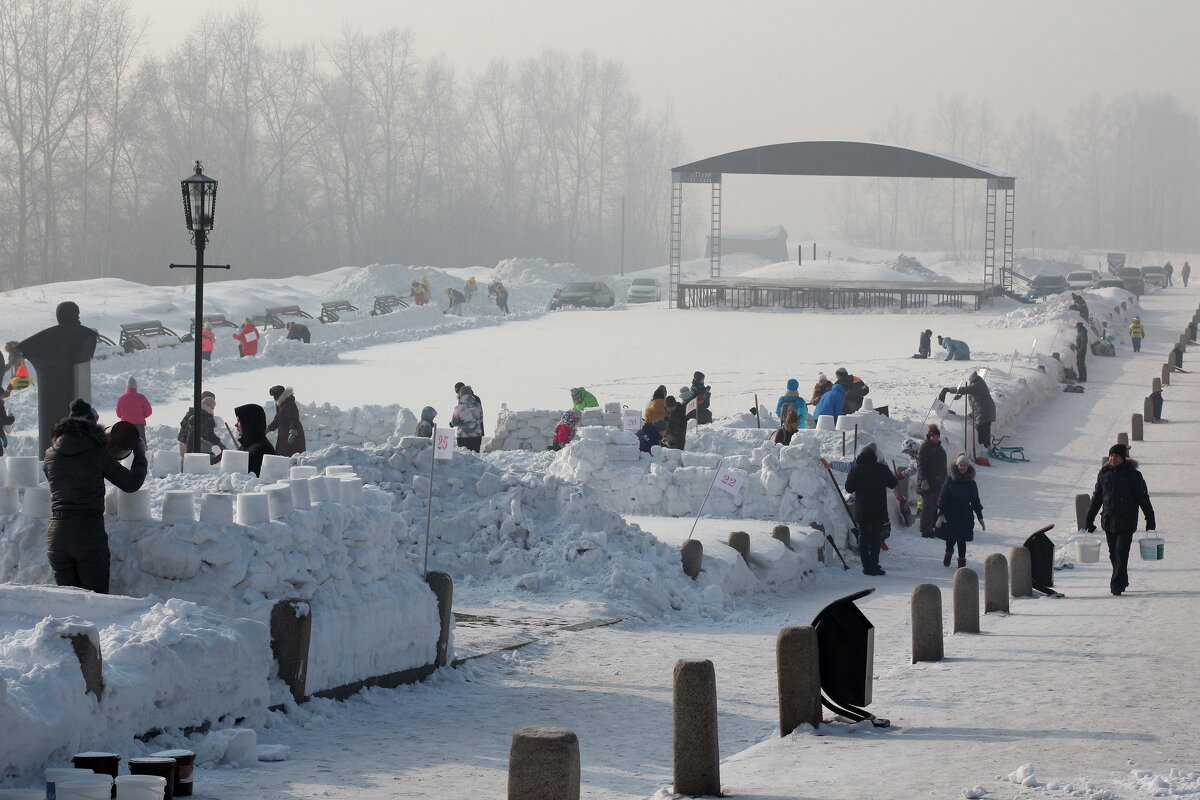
top-left (671, 658), bottom-right (721, 796)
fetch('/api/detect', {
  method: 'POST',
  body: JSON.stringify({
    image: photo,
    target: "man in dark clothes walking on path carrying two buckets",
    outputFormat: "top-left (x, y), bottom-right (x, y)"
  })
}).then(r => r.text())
top-left (1086, 445), bottom-right (1154, 595)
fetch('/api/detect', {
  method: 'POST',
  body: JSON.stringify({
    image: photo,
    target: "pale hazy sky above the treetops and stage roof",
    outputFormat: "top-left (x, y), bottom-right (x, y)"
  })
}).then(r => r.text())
top-left (132, 0), bottom-right (1200, 240)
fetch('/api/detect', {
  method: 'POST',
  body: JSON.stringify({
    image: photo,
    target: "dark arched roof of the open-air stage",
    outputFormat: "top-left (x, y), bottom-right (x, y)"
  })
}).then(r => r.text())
top-left (671, 142), bottom-right (1015, 188)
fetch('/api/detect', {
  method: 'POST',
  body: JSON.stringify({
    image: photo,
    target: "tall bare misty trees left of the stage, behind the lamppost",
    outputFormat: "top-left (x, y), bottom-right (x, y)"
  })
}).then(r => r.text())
top-left (0, 0), bottom-right (683, 289)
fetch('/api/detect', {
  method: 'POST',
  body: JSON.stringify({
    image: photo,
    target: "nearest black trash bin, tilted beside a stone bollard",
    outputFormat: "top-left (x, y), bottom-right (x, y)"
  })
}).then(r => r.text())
top-left (812, 589), bottom-right (889, 727)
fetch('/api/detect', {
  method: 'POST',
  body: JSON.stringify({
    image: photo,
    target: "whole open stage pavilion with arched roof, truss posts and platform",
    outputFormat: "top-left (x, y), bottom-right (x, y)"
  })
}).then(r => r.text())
top-left (668, 142), bottom-right (1019, 308)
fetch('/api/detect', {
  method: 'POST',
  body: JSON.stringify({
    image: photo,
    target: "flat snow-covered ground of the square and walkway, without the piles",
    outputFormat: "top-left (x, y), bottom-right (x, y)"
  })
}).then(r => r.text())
top-left (0, 252), bottom-right (1200, 800)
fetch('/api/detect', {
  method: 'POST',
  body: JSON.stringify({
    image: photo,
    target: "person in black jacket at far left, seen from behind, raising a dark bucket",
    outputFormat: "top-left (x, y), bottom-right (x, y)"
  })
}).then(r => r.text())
top-left (42, 399), bottom-right (146, 595)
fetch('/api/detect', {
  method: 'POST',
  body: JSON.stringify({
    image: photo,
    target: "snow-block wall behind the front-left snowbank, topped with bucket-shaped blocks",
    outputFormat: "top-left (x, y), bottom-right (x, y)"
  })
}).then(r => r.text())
top-left (0, 475), bottom-right (440, 692)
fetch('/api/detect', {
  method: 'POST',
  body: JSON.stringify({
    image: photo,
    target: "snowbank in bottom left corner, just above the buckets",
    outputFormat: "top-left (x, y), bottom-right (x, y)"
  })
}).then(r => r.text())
top-left (0, 585), bottom-right (271, 783)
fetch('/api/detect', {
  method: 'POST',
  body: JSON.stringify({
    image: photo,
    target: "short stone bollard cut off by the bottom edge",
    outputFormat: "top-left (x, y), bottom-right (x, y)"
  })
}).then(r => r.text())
top-left (509, 726), bottom-right (580, 800)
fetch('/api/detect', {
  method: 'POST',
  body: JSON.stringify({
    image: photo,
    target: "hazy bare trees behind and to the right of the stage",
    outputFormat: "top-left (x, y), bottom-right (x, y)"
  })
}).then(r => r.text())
top-left (833, 94), bottom-right (1200, 258)
